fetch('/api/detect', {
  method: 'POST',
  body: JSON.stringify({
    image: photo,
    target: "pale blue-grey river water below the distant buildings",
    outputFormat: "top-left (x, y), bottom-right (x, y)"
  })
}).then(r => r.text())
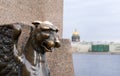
top-left (73, 54), bottom-right (120, 76)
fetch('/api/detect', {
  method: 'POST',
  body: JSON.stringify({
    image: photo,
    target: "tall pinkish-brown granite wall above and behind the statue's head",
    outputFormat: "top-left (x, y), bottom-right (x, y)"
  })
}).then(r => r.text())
top-left (0, 0), bottom-right (63, 37)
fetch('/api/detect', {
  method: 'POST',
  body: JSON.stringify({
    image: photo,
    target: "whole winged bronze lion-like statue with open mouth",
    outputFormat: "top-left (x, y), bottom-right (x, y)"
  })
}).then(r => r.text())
top-left (0, 21), bottom-right (60, 76)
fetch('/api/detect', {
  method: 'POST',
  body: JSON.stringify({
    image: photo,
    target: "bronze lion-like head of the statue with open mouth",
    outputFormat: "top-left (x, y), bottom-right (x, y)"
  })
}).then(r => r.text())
top-left (31, 21), bottom-right (60, 52)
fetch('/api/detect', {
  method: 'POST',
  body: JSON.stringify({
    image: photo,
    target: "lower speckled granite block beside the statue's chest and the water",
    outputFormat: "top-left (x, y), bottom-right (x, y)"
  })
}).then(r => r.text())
top-left (47, 39), bottom-right (74, 76)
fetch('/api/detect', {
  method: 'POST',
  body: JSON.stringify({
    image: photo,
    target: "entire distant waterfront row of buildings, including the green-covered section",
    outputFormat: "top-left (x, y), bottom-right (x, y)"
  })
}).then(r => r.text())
top-left (71, 41), bottom-right (120, 54)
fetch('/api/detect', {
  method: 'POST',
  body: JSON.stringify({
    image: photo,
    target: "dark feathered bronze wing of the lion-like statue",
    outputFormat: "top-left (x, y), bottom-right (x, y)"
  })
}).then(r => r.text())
top-left (0, 23), bottom-right (21, 76)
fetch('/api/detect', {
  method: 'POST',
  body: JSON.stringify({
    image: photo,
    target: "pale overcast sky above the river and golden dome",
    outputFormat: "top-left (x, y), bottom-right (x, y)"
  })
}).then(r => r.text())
top-left (63, 0), bottom-right (120, 41)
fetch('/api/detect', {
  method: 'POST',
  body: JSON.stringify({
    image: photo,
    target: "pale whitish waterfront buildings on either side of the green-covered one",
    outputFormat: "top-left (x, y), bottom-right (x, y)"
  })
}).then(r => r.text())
top-left (71, 42), bottom-right (120, 53)
